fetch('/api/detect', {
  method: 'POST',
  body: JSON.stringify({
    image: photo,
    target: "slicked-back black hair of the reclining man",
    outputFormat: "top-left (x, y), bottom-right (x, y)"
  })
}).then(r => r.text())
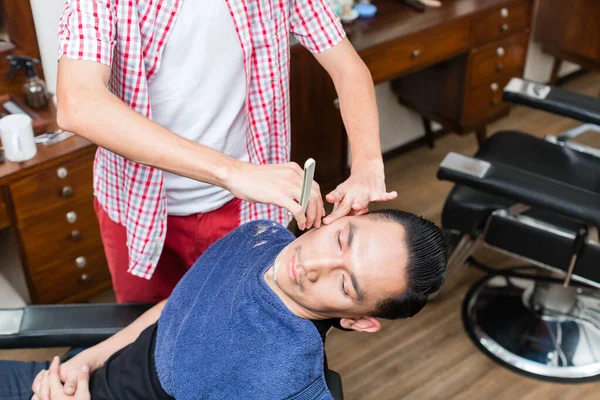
top-left (367, 210), bottom-right (448, 319)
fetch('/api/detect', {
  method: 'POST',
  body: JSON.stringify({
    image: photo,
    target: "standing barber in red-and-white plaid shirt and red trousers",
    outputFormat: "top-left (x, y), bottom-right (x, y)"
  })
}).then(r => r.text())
top-left (57, 0), bottom-right (396, 302)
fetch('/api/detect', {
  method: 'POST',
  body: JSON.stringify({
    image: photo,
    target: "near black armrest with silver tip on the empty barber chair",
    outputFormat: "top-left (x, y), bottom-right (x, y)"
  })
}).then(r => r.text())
top-left (437, 153), bottom-right (600, 227)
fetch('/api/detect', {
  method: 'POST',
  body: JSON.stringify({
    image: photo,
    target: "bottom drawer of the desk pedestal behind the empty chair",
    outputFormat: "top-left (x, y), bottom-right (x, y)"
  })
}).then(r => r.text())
top-left (462, 74), bottom-right (511, 124)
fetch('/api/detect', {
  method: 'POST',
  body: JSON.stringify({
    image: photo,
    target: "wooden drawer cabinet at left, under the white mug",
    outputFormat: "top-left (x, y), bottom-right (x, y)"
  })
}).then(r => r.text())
top-left (0, 104), bottom-right (111, 304)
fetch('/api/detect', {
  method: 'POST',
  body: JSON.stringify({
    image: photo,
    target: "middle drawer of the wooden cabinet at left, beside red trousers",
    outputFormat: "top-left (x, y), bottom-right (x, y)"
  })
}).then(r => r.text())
top-left (20, 201), bottom-right (102, 273)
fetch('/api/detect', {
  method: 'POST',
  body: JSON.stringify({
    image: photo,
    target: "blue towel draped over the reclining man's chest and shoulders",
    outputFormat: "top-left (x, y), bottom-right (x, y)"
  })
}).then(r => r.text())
top-left (155, 221), bottom-right (332, 400)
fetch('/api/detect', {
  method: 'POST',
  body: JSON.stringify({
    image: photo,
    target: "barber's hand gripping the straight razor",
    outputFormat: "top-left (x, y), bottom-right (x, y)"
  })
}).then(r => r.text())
top-left (225, 159), bottom-right (325, 230)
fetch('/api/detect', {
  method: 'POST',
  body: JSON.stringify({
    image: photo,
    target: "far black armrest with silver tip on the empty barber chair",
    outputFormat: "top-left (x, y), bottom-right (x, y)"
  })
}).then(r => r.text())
top-left (502, 78), bottom-right (600, 125)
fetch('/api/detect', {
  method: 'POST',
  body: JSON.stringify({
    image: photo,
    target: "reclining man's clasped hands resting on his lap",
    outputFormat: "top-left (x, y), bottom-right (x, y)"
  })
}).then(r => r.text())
top-left (32, 357), bottom-right (91, 400)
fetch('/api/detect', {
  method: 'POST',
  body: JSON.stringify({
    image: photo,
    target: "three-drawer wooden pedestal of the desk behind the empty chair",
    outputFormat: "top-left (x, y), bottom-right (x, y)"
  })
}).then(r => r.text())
top-left (392, 0), bottom-right (533, 140)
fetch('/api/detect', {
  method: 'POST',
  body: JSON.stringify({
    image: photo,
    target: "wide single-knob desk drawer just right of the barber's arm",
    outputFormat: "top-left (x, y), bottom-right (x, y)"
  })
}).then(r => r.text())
top-left (360, 20), bottom-right (470, 83)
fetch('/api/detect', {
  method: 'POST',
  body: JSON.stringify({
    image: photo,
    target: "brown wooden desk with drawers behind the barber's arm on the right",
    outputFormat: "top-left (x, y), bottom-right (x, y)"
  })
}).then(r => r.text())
top-left (290, 0), bottom-right (532, 192)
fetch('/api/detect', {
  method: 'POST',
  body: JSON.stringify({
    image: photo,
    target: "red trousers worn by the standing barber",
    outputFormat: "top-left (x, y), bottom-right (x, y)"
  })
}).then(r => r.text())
top-left (94, 199), bottom-right (241, 303)
